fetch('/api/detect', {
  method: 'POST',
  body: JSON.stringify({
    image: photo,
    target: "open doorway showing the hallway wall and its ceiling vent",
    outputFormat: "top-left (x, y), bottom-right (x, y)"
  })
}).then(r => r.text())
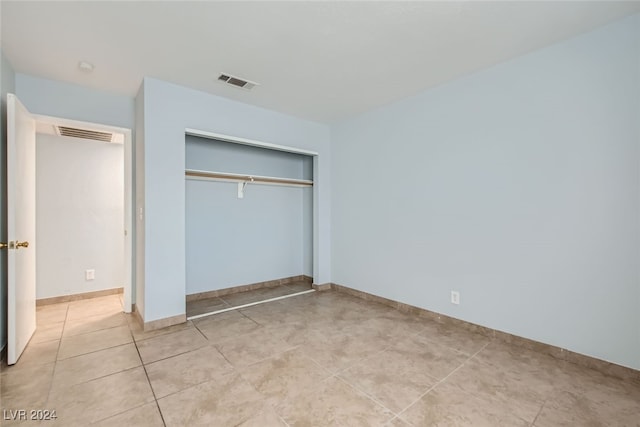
top-left (34, 115), bottom-right (133, 313)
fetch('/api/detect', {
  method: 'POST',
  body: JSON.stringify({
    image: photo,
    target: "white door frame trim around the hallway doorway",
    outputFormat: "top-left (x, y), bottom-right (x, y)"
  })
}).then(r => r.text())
top-left (33, 114), bottom-right (135, 313)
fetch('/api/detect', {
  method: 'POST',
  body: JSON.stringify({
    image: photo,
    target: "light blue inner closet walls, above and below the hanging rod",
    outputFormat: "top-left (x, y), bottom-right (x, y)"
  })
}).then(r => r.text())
top-left (185, 136), bottom-right (313, 295)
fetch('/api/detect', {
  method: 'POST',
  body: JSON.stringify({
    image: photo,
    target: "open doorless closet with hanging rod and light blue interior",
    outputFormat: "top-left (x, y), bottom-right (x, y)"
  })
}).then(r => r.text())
top-left (185, 130), bottom-right (317, 320)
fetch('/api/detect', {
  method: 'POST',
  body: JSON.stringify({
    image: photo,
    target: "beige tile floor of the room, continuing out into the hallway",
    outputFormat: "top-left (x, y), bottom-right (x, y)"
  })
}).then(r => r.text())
top-left (0, 291), bottom-right (640, 427)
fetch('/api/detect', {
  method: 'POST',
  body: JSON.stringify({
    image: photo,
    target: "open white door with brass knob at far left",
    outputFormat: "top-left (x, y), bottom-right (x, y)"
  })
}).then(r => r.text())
top-left (7, 94), bottom-right (36, 365)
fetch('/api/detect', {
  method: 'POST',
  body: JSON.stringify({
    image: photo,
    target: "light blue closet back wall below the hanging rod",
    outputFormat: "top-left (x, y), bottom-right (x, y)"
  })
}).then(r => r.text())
top-left (186, 180), bottom-right (311, 295)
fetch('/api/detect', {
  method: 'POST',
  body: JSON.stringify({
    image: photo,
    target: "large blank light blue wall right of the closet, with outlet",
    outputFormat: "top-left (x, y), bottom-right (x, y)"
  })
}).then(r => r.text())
top-left (331, 15), bottom-right (640, 369)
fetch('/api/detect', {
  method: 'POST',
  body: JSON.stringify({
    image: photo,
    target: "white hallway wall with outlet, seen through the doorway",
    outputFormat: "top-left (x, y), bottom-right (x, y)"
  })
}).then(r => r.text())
top-left (35, 133), bottom-right (125, 299)
